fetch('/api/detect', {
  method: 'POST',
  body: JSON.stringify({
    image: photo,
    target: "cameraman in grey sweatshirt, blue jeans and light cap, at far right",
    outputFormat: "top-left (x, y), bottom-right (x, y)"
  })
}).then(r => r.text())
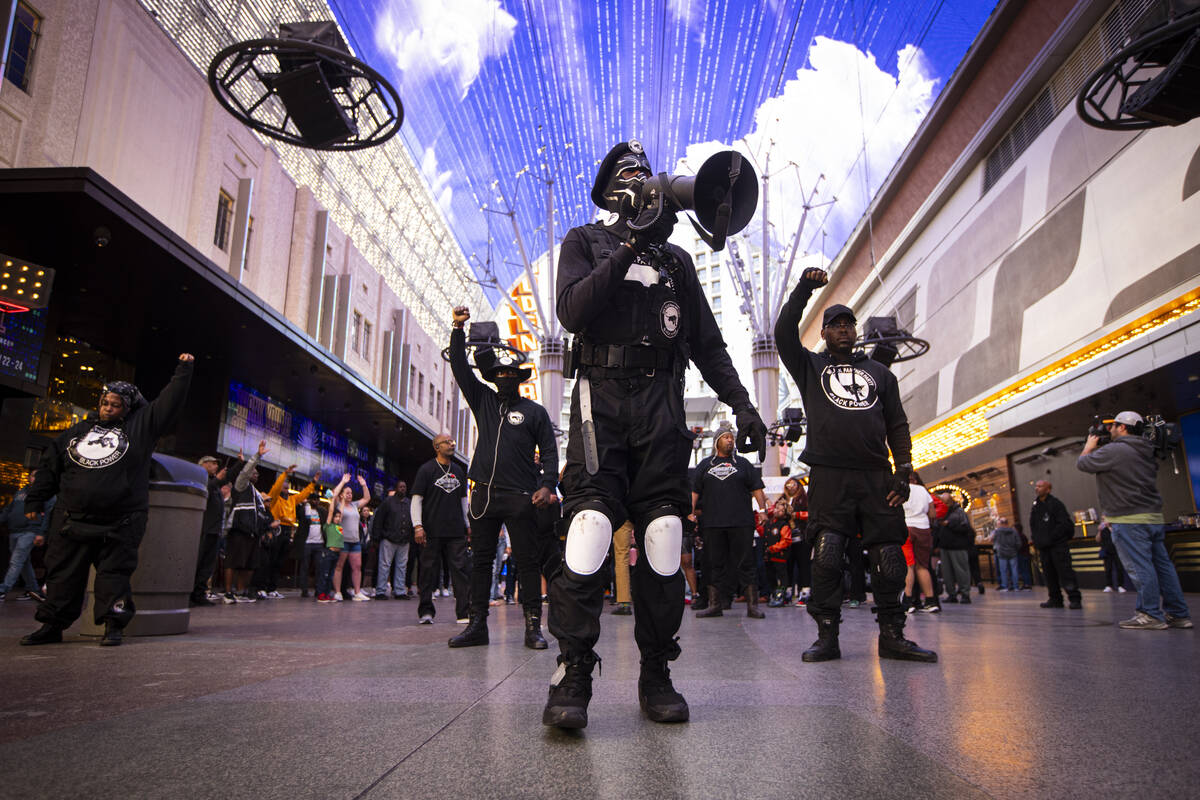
top-left (1076, 411), bottom-right (1192, 631)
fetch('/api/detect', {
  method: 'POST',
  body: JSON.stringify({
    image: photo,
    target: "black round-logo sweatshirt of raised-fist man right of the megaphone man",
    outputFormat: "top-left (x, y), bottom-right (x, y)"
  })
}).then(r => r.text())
top-left (775, 278), bottom-right (912, 469)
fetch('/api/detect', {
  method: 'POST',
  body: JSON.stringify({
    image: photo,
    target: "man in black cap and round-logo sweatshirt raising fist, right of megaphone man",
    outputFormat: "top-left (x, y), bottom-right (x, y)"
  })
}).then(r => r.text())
top-left (775, 269), bottom-right (937, 662)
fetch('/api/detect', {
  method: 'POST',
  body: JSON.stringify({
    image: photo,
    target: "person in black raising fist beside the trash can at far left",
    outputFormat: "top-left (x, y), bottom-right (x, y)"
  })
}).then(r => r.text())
top-left (20, 353), bottom-right (194, 645)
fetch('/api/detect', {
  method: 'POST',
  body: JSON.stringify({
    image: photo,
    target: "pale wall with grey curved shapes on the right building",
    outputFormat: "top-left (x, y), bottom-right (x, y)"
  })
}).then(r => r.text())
top-left (862, 108), bottom-right (1200, 429)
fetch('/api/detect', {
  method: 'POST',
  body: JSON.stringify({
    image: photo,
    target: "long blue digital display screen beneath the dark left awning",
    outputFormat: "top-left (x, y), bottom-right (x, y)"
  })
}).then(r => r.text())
top-left (218, 383), bottom-right (396, 494)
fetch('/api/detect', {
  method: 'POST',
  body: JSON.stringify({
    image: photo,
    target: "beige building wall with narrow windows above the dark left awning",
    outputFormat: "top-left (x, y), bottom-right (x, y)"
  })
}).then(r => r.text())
top-left (0, 0), bottom-right (477, 443)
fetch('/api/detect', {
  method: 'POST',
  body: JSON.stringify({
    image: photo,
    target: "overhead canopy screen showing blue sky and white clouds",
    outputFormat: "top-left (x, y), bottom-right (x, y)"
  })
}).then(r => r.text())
top-left (330, 0), bottom-right (996, 297)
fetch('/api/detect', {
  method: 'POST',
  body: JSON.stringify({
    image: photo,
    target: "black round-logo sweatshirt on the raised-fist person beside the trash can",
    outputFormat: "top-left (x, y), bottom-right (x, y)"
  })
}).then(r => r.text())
top-left (25, 361), bottom-right (192, 522)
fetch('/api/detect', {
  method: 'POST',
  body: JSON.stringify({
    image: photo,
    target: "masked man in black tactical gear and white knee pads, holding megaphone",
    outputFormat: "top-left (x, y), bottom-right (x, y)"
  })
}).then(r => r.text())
top-left (542, 140), bottom-right (766, 728)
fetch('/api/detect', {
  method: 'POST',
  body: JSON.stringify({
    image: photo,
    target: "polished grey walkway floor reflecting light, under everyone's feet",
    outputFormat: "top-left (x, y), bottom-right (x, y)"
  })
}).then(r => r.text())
top-left (0, 591), bottom-right (1200, 800)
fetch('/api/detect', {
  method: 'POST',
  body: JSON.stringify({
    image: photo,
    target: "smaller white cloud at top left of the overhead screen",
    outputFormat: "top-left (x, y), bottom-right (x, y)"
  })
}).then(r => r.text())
top-left (374, 0), bottom-right (517, 97)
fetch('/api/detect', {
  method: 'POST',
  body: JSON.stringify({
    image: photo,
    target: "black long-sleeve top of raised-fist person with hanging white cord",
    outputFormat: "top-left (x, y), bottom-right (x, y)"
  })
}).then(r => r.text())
top-left (450, 327), bottom-right (558, 494)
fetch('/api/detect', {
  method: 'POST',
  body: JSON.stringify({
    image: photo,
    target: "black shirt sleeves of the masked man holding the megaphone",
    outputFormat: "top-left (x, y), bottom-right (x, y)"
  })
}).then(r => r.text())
top-left (557, 223), bottom-right (752, 410)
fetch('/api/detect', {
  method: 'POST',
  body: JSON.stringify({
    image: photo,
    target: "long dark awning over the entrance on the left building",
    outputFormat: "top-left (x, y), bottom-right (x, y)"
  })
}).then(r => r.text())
top-left (0, 168), bottom-right (446, 475)
